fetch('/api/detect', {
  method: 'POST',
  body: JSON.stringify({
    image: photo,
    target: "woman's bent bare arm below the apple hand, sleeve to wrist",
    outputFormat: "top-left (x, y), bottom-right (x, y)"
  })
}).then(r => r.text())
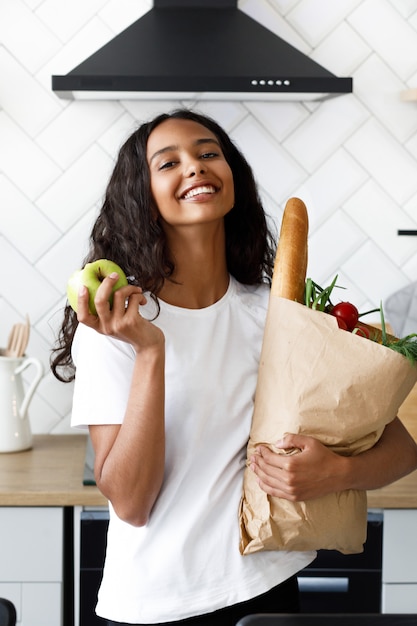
top-left (90, 349), bottom-right (165, 526)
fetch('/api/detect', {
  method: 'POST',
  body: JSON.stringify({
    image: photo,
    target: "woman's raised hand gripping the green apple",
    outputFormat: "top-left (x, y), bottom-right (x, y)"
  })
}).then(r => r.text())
top-left (77, 273), bottom-right (164, 352)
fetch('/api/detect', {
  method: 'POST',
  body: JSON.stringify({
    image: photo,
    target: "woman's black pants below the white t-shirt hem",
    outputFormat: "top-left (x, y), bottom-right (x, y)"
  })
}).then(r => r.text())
top-left (107, 576), bottom-right (299, 626)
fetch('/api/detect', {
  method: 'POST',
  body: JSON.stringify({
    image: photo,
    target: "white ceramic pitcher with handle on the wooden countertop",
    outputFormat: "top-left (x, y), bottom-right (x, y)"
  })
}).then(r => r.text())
top-left (0, 349), bottom-right (43, 452)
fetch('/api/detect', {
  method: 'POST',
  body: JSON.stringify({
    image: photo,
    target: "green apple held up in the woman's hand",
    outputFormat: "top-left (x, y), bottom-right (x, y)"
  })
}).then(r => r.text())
top-left (67, 259), bottom-right (128, 315)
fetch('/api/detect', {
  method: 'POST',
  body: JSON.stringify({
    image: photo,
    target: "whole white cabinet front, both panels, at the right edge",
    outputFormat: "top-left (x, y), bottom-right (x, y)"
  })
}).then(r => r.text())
top-left (382, 509), bottom-right (417, 613)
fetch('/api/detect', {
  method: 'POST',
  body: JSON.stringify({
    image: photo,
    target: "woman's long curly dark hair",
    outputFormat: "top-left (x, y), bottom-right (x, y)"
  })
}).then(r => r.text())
top-left (51, 109), bottom-right (275, 382)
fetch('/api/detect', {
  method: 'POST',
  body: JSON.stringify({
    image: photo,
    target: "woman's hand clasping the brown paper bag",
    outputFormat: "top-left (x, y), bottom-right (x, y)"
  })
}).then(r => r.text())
top-left (250, 434), bottom-right (347, 501)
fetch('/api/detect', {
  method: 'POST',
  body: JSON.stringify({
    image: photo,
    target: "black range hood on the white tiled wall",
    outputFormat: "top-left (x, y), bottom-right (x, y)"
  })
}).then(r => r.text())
top-left (52, 0), bottom-right (352, 100)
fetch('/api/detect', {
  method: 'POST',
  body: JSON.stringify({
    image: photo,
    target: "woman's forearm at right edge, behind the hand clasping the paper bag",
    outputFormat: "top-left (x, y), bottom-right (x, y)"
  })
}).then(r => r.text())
top-left (341, 418), bottom-right (417, 490)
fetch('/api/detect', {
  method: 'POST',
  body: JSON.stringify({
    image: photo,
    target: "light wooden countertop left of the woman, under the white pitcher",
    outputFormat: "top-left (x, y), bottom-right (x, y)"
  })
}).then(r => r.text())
top-left (0, 435), bottom-right (107, 506)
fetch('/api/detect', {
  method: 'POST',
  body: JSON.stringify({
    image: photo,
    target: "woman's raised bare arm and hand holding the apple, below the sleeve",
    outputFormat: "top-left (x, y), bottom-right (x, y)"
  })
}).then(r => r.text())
top-left (77, 274), bottom-right (165, 526)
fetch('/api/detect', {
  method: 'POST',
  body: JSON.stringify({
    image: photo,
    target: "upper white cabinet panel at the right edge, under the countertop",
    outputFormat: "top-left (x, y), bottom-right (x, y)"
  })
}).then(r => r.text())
top-left (382, 509), bottom-right (417, 583)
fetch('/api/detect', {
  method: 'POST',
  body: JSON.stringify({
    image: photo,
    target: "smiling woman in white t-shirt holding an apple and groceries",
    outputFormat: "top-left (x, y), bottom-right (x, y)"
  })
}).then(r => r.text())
top-left (52, 110), bottom-right (417, 626)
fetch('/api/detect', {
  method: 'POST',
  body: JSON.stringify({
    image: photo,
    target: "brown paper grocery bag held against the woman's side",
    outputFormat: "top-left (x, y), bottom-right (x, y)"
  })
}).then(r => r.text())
top-left (239, 296), bottom-right (417, 554)
